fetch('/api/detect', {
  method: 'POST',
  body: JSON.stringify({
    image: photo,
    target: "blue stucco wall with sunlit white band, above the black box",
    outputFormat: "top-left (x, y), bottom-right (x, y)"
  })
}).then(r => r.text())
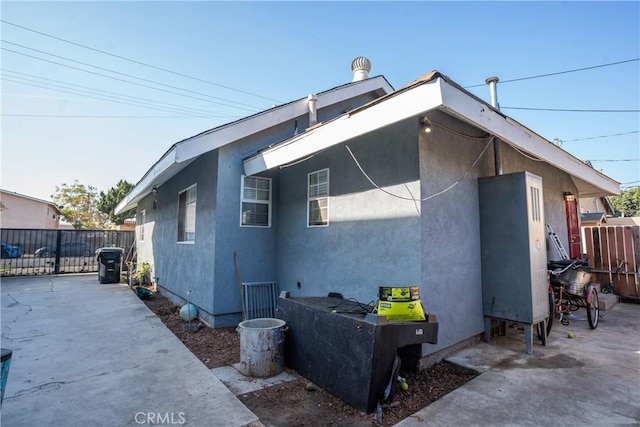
top-left (278, 120), bottom-right (421, 303)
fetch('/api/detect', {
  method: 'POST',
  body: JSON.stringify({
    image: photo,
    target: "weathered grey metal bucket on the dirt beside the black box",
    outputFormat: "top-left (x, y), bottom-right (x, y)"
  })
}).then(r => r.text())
top-left (237, 318), bottom-right (287, 378)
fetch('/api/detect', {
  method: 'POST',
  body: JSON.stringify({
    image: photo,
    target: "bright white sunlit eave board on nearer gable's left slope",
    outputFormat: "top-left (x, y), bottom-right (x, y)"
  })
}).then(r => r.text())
top-left (244, 79), bottom-right (442, 175)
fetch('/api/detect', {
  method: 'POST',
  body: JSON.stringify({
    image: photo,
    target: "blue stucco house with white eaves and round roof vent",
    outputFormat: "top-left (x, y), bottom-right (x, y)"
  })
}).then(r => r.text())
top-left (116, 58), bottom-right (619, 362)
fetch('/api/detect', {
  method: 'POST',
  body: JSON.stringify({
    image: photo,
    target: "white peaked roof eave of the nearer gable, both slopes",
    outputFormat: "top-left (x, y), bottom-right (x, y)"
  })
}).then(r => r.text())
top-left (244, 74), bottom-right (620, 196)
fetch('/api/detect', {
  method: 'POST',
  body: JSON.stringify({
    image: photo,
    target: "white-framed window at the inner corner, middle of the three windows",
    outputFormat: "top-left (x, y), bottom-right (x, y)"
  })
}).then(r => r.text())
top-left (240, 176), bottom-right (271, 227)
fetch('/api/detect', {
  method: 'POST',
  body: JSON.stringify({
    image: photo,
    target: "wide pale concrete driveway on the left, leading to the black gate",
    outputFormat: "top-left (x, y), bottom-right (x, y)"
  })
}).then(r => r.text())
top-left (1, 274), bottom-right (257, 427)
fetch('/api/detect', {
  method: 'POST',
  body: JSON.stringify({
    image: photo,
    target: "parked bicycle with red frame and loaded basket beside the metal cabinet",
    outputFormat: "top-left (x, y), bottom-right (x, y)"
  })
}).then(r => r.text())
top-left (536, 260), bottom-right (600, 343)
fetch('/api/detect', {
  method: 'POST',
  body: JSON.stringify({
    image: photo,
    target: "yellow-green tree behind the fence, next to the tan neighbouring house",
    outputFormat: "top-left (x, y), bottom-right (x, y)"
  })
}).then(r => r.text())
top-left (51, 180), bottom-right (111, 230)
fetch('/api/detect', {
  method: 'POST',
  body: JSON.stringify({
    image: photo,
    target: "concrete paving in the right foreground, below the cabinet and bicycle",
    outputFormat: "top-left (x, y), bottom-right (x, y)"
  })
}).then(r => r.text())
top-left (396, 303), bottom-right (640, 427)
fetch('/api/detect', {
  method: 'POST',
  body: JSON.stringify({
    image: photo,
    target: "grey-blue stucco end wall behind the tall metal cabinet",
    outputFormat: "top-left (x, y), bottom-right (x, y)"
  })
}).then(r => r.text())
top-left (420, 113), bottom-right (577, 355)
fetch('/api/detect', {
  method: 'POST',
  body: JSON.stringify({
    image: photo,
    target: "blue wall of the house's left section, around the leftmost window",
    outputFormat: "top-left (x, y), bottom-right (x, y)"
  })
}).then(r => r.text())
top-left (138, 88), bottom-right (375, 327)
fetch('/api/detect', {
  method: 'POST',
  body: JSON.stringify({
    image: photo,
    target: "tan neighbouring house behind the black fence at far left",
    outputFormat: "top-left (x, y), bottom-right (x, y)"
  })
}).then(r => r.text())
top-left (0, 190), bottom-right (61, 229)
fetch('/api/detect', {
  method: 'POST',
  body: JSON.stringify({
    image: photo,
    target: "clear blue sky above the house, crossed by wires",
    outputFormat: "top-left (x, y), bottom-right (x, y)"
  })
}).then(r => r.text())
top-left (0, 1), bottom-right (640, 199)
